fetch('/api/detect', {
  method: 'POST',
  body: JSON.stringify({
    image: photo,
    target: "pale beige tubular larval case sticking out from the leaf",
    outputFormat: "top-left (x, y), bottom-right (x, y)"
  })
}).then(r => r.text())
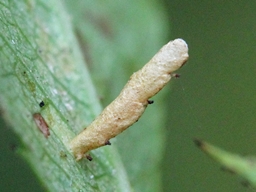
top-left (70, 39), bottom-right (188, 160)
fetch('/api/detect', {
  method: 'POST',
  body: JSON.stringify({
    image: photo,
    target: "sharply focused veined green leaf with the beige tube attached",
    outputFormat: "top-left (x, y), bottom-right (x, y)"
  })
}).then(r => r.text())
top-left (0, 0), bottom-right (130, 191)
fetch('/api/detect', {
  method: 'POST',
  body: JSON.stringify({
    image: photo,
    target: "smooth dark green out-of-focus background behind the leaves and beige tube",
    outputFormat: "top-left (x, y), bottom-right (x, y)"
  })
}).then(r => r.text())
top-left (0, 0), bottom-right (256, 192)
